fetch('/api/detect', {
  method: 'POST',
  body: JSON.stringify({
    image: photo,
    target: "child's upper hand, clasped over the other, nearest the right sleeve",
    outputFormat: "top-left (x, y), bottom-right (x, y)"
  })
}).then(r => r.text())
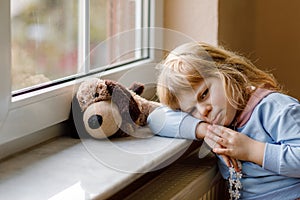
top-left (206, 125), bottom-right (265, 165)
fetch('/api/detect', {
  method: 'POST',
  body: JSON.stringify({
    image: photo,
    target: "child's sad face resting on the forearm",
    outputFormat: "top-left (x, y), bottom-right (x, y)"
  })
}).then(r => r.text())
top-left (178, 78), bottom-right (236, 126)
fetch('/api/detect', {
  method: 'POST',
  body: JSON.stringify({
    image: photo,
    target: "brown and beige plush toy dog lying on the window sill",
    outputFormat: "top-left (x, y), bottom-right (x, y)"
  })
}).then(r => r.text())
top-left (72, 78), bottom-right (160, 139)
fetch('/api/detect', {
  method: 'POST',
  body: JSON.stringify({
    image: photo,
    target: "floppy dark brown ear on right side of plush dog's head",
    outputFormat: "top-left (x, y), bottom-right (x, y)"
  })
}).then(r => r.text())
top-left (106, 80), bottom-right (141, 129)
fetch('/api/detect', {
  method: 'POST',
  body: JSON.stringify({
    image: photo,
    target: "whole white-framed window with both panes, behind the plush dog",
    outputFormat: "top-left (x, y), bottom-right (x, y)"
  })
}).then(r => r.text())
top-left (0, 0), bottom-right (162, 157)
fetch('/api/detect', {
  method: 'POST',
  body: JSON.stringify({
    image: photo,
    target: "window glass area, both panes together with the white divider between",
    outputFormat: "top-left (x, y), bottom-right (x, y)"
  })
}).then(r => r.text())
top-left (11, 0), bottom-right (148, 95)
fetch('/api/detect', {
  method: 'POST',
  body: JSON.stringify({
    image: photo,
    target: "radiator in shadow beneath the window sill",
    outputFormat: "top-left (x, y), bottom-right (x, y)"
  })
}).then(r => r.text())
top-left (125, 152), bottom-right (228, 200)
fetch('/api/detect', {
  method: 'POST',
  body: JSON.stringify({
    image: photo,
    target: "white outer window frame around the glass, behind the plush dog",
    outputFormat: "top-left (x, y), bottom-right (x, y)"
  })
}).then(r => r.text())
top-left (0, 0), bottom-right (163, 159)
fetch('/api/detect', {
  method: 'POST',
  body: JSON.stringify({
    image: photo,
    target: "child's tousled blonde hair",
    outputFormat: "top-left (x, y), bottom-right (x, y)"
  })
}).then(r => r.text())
top-left (157, 42), bottom-right (281, 110)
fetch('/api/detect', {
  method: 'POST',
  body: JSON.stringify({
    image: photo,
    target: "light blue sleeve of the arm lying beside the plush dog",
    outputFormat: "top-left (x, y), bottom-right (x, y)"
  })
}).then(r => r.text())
top-left (147, 106), bottom-right (201, 140)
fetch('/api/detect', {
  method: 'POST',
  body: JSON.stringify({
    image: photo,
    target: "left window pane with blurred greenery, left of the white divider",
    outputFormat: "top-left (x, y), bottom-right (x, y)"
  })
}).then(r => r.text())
top-left (11, 0), bottom-right (78, 90)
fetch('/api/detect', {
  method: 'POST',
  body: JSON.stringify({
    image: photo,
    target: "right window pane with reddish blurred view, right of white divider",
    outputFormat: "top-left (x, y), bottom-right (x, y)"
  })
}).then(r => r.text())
top-left (90, 0), bottom-right (147, 70)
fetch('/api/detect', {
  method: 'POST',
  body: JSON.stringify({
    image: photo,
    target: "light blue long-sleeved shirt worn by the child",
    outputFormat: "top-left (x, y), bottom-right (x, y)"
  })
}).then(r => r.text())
top-left (148, 93), bottom-right (300, 200)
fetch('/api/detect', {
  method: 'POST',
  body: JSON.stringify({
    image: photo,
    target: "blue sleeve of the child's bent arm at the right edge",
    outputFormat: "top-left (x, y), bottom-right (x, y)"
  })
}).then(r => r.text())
top-left (263, 94), bottom-right (300, 177)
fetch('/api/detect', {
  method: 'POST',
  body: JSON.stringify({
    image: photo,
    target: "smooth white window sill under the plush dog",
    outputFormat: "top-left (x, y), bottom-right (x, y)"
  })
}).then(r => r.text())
top-left (0, 128), bottom-right (204, 200)
